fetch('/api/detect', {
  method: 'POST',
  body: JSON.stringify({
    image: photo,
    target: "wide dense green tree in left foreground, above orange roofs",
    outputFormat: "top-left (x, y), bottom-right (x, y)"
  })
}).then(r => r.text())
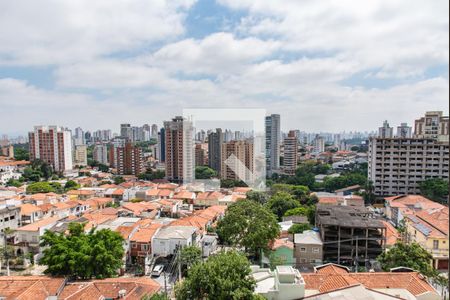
top-left (40, 223), bottom-right (124, 279)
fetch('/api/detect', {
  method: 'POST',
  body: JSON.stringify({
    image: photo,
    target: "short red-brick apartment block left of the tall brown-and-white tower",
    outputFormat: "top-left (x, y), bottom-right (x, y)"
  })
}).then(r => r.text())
top-left (117, 142), bottom-right (145, 176)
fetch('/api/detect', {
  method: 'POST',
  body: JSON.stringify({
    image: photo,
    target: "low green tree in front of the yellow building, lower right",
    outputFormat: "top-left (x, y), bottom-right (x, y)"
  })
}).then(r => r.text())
top-left (377, 242), bottom-right (437, 277)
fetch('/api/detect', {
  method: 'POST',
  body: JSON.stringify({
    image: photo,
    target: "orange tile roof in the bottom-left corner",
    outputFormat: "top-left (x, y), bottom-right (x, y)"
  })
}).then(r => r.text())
top-left (0, 276), bottom-right (65, 300)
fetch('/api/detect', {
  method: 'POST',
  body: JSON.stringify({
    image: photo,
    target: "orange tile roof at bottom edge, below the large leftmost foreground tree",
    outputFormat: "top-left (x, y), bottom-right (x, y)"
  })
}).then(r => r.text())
top-left (58, 277), bottom-right (160, 300)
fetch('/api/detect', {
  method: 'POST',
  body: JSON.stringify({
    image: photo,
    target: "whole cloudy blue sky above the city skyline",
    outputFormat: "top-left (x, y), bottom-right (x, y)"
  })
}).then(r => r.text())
top-left (0, 0), bottom-right (449, 135)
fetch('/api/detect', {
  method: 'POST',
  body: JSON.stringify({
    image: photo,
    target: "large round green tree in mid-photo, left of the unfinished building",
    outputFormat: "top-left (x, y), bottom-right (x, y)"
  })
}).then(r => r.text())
top-left (217, 200), bottom-right (280, 256)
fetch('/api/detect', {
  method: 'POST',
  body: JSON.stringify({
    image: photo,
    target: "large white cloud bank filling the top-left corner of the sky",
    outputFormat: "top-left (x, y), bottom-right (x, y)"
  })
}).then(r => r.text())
top-left (0, 0), bottom-right (195, 65)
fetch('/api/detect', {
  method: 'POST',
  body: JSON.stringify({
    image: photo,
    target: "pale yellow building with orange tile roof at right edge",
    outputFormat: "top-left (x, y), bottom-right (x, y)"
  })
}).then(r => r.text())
top-left (405, 206), bottom-right (449, 270)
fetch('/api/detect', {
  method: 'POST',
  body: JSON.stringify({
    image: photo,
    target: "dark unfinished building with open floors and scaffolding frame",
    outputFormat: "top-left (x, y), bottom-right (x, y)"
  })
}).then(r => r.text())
top-left (316, 204), bottom-right (386, 267)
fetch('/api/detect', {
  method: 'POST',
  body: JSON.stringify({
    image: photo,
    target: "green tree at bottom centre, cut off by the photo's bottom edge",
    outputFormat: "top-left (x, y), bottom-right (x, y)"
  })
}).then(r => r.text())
top-left (175, 250), bottom-right (256, 300)
